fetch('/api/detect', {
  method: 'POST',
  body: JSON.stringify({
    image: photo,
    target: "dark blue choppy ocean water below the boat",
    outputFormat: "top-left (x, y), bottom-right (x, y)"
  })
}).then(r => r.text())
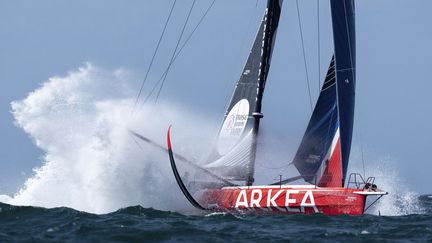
top-left (0, 195), bottom-right (432, 242)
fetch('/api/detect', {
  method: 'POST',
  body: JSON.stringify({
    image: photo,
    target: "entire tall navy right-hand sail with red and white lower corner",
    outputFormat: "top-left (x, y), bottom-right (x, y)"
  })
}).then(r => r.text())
top-left (293, 0), bottom-right (355, 187)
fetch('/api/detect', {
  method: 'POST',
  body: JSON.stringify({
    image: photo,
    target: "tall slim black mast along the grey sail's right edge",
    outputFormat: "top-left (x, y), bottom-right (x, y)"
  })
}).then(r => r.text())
top-left (246, 0), bottom-right (282, 186)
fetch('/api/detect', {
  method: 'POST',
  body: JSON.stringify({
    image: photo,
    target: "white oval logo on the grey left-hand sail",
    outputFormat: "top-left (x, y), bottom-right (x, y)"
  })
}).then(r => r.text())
top-left (218, 99), bottom-right (249, 155)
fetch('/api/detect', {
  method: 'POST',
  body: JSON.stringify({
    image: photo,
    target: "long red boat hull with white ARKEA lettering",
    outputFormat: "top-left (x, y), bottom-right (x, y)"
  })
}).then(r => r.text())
top-left (199, 185), bottom-right (366, 215)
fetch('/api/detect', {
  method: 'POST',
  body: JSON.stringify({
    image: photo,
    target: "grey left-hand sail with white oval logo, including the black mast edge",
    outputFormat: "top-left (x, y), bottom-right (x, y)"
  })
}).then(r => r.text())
top-left (206, 0), bottom-right (282, 184)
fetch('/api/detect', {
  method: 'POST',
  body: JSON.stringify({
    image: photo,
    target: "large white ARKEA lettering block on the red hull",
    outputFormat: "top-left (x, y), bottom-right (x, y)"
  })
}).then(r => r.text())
top-left (235, 189), bottom-right (319, 213)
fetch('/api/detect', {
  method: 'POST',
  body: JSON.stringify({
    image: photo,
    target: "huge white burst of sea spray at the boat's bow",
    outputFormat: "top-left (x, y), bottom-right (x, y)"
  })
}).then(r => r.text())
top-left (7, 64), bottom-right (214, 213)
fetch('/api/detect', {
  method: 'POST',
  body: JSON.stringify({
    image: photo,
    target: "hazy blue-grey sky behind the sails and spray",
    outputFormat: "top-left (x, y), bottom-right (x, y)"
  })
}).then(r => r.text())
top-left (0, 0), bottom-right (432, 195)
